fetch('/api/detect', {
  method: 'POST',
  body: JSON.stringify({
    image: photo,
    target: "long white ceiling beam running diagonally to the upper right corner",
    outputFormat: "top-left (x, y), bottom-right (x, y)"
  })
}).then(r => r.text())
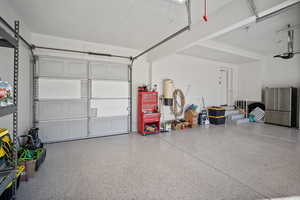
top-left (148, 0), bottom-right (300, 61)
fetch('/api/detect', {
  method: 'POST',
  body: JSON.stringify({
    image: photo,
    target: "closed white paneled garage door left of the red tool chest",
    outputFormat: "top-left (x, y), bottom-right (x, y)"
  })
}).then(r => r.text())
top-left (35, 57), bottom-right (129, 142)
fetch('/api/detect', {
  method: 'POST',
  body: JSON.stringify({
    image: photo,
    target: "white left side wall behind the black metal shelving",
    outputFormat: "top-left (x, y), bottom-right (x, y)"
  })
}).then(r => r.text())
top-left (0, 0), bottom-right (32, 134)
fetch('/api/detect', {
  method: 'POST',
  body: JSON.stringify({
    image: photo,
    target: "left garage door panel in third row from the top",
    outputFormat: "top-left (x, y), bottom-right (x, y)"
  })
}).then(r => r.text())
top-left (36, 100), bottom-right (87, 121)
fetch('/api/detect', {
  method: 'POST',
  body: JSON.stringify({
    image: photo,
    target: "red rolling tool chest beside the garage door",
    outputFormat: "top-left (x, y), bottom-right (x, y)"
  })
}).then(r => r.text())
top-left (138, 91), bottom-right (160, 135)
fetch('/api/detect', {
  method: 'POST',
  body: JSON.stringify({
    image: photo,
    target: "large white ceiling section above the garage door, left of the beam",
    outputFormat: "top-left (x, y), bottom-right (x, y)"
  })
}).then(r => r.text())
top-left (10, 0), bottom-right (232, 49)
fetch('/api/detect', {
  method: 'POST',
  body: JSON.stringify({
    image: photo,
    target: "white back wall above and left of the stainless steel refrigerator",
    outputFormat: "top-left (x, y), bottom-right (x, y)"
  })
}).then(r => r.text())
top-left (238, 55), bottom-right (300, 101)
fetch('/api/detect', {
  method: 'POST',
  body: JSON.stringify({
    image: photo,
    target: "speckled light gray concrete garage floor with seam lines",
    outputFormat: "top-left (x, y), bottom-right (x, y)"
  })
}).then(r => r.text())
top-left (17, 124), bottom-right (300, 200)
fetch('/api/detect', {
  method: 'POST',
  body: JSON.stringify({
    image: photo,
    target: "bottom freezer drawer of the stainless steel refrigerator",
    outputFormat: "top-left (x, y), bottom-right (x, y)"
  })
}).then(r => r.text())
top-left (265, 111), bottom-right (292, 126)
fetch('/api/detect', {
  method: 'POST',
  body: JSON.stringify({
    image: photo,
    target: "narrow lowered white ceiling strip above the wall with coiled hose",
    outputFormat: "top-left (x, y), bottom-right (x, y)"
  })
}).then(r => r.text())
top-left (179, 45), bottom-right (257, 64)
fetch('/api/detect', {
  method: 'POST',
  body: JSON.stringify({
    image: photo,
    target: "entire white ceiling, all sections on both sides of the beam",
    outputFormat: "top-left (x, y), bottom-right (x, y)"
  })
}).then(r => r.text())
top-left (10, 0), bottom-right (300, 64)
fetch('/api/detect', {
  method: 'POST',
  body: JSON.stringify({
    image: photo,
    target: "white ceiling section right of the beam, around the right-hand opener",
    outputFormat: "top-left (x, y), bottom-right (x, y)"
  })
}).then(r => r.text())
top-left (214, 0), bottom-right (300, 55)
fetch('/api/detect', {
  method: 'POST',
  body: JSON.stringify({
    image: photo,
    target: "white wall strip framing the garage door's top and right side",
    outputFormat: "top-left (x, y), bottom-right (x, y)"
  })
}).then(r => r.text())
top-left (32, 33), bottom-right (149, 130)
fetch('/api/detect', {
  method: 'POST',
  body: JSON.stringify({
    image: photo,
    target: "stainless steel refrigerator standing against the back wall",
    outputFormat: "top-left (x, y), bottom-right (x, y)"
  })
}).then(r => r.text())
top-left (264, 87), bottom-right (298, 127)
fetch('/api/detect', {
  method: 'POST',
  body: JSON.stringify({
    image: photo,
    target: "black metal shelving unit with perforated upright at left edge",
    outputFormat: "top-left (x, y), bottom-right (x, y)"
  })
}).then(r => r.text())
top-left (0, 21), bottom-right (19, 199)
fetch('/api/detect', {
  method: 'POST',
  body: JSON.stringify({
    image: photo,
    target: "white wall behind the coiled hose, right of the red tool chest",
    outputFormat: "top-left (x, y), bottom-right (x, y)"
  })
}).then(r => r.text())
top-left (152, 55), bottom-right (237, 120)
